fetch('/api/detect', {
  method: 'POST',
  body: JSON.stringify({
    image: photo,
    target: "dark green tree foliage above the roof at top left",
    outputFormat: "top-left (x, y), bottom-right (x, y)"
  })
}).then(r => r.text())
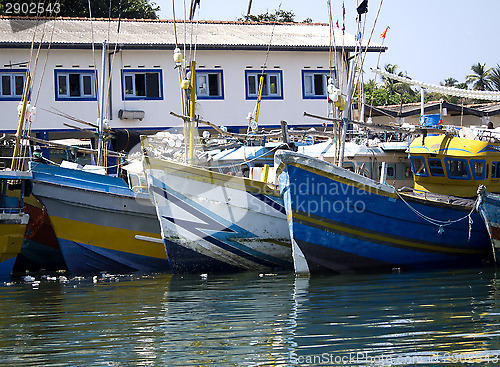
top-left (0, 0), bottom-right (160, 19)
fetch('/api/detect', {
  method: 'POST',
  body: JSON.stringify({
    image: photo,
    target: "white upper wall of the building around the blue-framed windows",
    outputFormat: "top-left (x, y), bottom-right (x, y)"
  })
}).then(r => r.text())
top-left (0, 45), bottom-right (346, 137)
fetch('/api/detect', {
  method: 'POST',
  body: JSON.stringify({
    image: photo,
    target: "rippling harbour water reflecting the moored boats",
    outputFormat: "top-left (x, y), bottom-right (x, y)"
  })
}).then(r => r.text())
top-left (0, 268), bottom-right (500, 366)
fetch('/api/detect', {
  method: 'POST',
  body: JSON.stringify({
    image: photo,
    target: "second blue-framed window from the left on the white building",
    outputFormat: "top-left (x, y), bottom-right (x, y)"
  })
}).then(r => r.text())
top-left (54, 69), bottom-right (97, 101)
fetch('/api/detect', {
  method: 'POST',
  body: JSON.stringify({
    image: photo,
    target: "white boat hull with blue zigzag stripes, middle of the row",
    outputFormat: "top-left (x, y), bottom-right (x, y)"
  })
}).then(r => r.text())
top-left (145, 159), bottom-right (292, 273)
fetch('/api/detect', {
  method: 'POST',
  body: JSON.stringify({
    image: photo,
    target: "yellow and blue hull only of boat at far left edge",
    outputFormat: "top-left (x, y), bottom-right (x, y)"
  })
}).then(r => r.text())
top-left (0, 213), bottom-right (29, 282)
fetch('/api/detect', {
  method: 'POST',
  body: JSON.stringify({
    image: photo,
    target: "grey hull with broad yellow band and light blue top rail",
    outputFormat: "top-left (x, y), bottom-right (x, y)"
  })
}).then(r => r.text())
top-left (32, 165), bottom-right (170, 275)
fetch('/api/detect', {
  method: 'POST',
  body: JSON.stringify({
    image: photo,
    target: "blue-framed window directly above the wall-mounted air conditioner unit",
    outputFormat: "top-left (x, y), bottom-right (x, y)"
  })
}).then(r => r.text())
top-left (122, 69), bottom-right (163, 101)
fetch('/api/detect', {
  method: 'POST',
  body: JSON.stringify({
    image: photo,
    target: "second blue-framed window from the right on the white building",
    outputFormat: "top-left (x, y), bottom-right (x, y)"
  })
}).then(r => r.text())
top-left (245, 70), bottom-right (283, 99)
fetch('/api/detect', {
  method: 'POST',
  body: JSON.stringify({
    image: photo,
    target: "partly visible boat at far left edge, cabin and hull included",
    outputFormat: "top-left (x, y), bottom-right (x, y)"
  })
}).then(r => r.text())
top-left (0, 171), bottom-right (31, 282)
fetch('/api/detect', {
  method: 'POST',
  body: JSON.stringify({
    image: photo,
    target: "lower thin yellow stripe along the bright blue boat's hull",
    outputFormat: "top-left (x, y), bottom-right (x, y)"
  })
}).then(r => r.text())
top-left (293, 213), bottom-right (483, 255)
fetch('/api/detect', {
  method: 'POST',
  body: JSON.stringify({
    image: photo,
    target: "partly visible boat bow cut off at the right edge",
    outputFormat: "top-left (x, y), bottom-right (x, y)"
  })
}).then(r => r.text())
top-left (476, 185), bottom-right (500, 264)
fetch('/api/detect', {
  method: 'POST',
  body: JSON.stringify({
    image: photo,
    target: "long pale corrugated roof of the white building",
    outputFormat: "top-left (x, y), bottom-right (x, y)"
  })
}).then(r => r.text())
top-left (0, 17), bottom-right (386, 51)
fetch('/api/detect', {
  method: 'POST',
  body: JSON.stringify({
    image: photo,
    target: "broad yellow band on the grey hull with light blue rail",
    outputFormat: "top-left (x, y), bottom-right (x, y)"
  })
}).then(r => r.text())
top-left (50, 216), bottom-right (167, 259)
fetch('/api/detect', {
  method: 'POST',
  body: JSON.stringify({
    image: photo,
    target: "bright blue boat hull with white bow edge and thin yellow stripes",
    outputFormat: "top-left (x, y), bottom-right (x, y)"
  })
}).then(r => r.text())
top-left (275, 151), bottom-right (491, 273)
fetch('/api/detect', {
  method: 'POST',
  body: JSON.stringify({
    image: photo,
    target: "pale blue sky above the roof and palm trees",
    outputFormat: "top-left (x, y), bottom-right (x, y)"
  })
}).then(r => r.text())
top-left (150, 0), bottom-right (500, 84)
